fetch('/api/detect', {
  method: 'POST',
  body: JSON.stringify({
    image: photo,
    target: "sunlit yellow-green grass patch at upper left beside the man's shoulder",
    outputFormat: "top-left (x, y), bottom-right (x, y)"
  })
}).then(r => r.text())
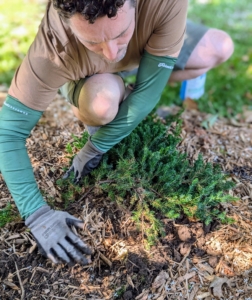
top-left (0, 0), bottom-right (45, 86)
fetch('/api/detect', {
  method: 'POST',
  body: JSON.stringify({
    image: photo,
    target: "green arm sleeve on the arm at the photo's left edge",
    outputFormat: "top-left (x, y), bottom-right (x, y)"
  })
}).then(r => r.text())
top-left (0, 95), bottom-right (46, 218)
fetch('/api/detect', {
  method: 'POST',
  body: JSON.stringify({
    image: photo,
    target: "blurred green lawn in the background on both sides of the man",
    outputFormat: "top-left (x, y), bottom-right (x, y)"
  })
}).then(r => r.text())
top-left (0, 0), bottom-right (252, 116)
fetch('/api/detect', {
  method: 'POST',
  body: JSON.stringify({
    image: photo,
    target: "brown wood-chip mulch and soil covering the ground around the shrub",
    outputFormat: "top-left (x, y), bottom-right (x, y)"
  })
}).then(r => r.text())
top-left (0, 91), bottom-right (252, 300)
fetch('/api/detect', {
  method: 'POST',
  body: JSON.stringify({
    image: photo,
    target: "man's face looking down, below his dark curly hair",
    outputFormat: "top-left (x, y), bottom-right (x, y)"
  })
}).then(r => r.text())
top-left (69, 1), bottom-right (135, 63)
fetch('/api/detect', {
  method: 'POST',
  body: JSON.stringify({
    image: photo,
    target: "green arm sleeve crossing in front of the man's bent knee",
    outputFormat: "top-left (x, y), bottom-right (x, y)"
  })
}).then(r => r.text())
top-left (91, 51), bottom-right (177, 152)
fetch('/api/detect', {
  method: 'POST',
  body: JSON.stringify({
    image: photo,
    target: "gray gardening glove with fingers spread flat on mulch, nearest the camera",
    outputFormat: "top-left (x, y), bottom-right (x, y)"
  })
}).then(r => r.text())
top-left (25, 205), bottom-right (92, 265)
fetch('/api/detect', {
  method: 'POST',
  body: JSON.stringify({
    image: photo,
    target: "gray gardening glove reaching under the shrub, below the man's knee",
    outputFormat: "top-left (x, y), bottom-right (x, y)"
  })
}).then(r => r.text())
top-left (63, 139), bottom-right (104, 184)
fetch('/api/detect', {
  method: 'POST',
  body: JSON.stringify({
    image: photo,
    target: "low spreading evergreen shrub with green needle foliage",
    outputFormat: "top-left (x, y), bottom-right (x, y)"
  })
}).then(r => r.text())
top-left (59, 116), bottom-right (235, 245)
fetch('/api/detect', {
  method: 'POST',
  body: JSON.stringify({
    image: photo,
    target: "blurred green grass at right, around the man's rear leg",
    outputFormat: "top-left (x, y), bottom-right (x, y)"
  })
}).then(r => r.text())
top-left (160, 0), bottom-right (252, 117)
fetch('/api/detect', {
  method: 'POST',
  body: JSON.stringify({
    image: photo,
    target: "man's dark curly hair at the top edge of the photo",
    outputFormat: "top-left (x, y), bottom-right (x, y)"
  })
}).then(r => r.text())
top-left (52, 0), bottom-right (136, 24)
